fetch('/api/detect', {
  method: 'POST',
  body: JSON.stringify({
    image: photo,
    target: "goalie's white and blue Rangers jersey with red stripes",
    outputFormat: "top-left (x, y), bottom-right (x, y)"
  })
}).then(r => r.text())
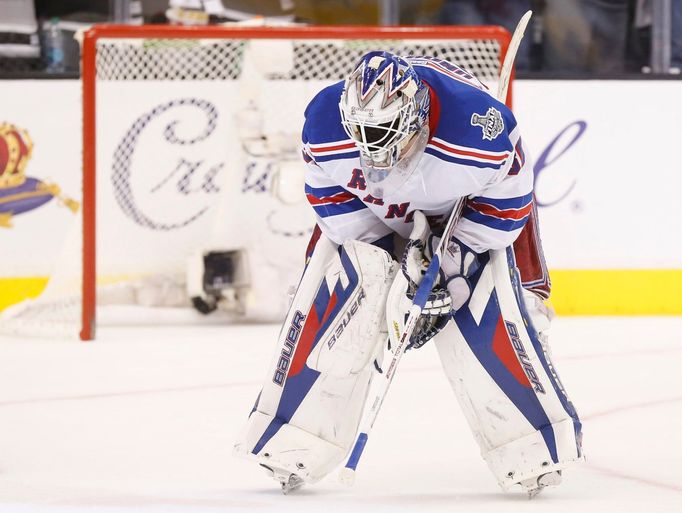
top-left (303, 57), bottom-right (534, 253)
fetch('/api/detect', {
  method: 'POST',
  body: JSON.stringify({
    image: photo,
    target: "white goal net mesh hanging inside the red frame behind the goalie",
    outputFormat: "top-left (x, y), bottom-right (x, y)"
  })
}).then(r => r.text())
top-left (0, 28), bottom-right (500, 336)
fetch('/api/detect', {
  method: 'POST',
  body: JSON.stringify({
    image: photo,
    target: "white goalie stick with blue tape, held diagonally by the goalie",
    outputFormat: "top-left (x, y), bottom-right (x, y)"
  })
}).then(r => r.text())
top-left (339, 11), bottom-right (533, 486)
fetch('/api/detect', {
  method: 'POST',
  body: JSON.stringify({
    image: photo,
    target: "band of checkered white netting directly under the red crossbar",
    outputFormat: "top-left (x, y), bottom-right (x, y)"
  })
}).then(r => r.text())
top-left (97, 39), bottom-right (500, 81)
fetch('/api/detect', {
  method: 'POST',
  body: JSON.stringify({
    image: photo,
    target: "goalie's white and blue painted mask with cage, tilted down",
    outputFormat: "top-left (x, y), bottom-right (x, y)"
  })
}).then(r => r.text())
top-left (339, 51), bottom-right (429, 198)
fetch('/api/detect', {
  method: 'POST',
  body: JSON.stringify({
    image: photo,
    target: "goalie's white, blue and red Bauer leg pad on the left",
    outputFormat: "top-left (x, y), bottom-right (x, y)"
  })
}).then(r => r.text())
top-left (235, 235), bottom-right (397, 483)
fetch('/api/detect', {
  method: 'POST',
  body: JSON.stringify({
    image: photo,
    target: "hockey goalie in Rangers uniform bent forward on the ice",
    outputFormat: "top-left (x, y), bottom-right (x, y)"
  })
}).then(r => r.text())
top-left (235, 51), bottom-right (582, 495)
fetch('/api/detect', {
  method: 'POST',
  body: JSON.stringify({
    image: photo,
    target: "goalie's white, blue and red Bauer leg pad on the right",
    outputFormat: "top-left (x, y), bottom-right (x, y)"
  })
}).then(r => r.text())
top-left (435, 248), bottom-right (582, 489)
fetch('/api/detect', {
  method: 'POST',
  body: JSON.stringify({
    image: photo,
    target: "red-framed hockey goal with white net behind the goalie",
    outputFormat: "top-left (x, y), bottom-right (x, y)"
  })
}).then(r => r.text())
top-left (0, 25), bottom-right (512, 340)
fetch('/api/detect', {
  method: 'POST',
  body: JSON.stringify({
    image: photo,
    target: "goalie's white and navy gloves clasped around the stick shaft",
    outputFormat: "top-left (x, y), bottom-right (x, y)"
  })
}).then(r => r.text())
top-left (401, 213), bottom-right (479, 349)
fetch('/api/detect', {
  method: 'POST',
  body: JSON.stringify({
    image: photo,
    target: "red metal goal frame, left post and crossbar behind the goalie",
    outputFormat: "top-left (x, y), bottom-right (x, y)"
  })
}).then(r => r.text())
top-left (80, 25), bottom-right (513, 340)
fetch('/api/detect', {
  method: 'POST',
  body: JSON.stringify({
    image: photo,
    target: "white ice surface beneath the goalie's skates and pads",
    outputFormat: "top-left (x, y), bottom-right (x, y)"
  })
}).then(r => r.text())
top-left (0, 318), bottom-right (682, 513)
